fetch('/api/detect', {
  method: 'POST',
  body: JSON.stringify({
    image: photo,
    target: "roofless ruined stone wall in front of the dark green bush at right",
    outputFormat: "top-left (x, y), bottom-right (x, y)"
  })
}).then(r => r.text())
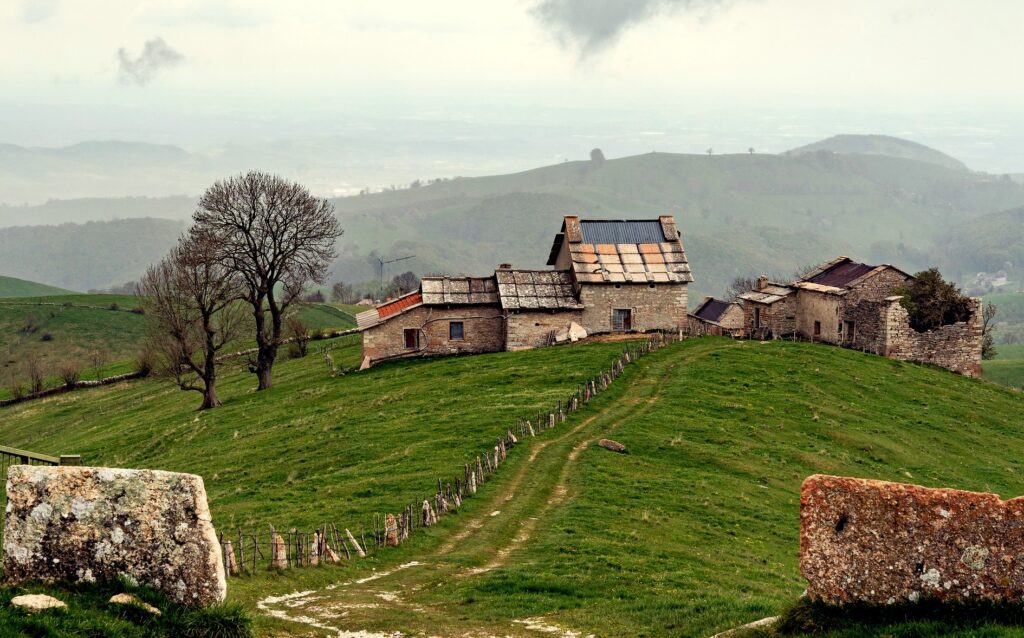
top-left (885, 298), bottom-right (982, 377)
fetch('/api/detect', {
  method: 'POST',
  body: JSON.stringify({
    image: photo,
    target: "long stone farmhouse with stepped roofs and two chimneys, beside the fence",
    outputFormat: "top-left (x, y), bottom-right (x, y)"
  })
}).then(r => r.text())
top-left (356, 215), bottom-right (693, 368)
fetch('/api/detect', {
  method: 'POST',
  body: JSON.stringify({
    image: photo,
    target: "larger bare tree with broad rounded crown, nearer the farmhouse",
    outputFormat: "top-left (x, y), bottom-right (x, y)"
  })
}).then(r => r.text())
top-left (193, 171), bottom-right (342, 390)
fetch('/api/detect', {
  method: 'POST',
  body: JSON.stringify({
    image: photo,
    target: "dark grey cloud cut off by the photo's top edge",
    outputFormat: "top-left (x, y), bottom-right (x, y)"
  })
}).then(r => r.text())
top-left (530, 0), bottom-right (734, 57)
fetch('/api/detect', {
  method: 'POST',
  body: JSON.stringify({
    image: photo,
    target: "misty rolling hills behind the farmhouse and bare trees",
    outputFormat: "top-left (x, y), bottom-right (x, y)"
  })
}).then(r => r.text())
top-left (0, 138), bottom-right (1024, 299)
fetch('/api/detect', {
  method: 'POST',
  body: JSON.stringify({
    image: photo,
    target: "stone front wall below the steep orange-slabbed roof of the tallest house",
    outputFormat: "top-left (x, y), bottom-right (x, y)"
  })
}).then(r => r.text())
top-left (580, 283), bottom-right (688, 334)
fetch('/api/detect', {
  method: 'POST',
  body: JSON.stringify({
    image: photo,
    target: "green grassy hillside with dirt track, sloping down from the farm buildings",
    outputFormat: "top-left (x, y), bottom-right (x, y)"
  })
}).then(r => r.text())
top-left (0, 338), bottom-right (1024, 636)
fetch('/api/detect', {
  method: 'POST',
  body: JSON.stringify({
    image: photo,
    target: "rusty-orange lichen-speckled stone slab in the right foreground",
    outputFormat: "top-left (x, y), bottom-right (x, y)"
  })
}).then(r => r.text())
top-left (800, 475), bottom-right (1024, 604)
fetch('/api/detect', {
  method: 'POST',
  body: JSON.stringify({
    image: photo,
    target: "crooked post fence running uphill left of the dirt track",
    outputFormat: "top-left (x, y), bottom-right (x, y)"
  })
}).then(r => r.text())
top-left (220, 331), bottom-right (684, 577)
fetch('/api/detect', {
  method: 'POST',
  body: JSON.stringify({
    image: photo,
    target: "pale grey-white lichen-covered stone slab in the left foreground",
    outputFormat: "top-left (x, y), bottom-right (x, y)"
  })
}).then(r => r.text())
top-left (3, 465), bottom-right (227, 606)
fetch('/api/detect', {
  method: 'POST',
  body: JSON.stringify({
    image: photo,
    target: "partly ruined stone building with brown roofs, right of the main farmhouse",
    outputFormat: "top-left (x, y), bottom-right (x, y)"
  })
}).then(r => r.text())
top-left (739, 257), bottom-right (982, 377)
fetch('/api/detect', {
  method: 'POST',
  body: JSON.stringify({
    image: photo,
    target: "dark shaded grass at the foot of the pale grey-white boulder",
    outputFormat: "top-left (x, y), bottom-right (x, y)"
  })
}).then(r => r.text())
top-left (0, 582), bottom-right (255, 638)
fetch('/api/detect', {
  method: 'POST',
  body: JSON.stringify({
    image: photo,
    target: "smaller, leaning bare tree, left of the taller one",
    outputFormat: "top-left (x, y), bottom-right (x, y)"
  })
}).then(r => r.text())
top-left (139, 232), bottom-right (245, 410)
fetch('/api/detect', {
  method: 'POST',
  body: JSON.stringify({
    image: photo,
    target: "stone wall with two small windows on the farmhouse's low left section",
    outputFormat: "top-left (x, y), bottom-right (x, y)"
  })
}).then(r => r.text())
top-left (362, 304), bottom-right (505, 365)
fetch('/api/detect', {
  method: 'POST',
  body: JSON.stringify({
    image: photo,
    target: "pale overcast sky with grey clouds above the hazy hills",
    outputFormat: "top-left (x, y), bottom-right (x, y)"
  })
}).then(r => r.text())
top-left (0, 0), bottom-right (1024, 171)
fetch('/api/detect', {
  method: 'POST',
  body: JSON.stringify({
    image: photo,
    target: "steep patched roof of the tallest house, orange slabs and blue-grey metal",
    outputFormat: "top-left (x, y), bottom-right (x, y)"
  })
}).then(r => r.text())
top-left (548, 215), bottom-right (693, 284)
